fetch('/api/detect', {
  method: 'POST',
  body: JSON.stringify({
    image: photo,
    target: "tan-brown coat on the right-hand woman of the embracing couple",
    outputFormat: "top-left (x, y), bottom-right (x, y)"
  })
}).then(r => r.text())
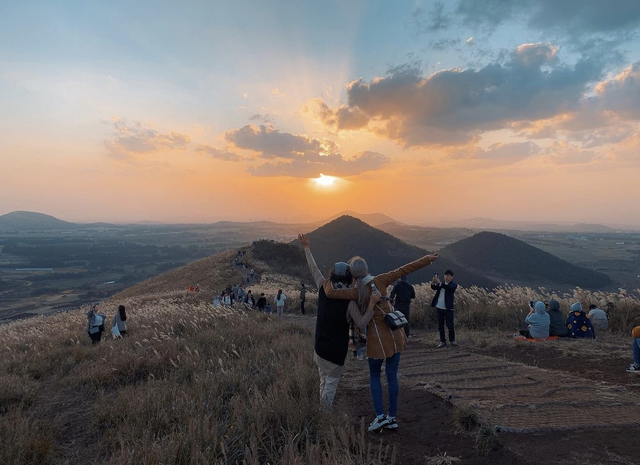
top-left (323, 256), bottom-right (438, 358)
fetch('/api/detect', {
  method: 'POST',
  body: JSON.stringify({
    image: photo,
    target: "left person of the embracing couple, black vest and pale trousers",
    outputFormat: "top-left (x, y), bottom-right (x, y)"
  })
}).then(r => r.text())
top-left (298, 234), bottom-right (377, 408)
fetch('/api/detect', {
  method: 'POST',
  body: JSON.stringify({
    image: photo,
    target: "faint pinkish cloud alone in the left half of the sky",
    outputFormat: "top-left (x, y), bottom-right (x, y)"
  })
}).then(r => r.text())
top-left (104, 117), bottom-right (191, 159)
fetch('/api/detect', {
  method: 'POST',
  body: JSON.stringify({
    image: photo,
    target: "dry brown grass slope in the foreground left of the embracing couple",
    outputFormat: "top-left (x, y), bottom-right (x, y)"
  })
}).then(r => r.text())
top-left (0, 293), bottom-right (395, 464)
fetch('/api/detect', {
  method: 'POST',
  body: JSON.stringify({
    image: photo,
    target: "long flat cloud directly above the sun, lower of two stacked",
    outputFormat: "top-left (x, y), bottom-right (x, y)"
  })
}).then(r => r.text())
top-left (249, 152), bottom-right (389, 178)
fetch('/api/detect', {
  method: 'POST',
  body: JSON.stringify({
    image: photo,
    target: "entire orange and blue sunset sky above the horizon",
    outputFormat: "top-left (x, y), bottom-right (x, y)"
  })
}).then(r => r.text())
top-left (0, 0), bottom-right (640, 225)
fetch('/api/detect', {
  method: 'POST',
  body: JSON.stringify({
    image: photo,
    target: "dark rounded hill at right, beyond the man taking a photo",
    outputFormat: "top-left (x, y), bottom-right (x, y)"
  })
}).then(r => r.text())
top-left (440, 232), bottom-right (613, 289)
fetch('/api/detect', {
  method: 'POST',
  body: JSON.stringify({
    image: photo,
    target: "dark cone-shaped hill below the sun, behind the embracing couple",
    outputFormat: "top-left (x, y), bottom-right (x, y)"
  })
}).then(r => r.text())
top-left (300, 216), bottom-right (496, 288)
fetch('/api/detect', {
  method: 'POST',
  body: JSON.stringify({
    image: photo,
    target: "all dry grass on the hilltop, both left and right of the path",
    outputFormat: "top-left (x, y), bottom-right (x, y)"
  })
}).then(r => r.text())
top-left (0, 272), bottom-right (640, 464)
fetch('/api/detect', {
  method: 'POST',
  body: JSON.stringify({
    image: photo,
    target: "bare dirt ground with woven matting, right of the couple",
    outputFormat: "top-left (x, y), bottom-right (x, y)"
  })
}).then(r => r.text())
top-left (336, 331), bottom-right (640, 465)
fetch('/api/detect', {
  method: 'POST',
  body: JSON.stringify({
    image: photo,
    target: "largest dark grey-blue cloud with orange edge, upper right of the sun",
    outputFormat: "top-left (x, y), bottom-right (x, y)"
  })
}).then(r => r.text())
top-left (312, 43), bottom-right (603, 147)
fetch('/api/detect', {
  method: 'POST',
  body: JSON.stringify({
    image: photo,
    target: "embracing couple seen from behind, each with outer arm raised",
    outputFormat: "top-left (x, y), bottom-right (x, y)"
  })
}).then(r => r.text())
top-left (298, 234), bottom-right (438, 432)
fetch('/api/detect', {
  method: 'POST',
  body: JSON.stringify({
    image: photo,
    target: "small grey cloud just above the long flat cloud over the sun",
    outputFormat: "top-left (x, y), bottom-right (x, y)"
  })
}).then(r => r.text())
top-left (225, 124), bottom-right (336, 158)
